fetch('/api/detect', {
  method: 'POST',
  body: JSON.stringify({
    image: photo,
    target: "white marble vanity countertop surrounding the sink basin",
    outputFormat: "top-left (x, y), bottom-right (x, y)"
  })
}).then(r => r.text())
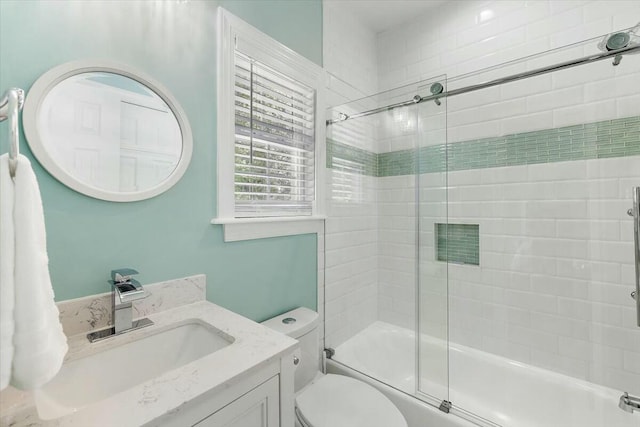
top-left (0, 292), bottom-right (297, 427)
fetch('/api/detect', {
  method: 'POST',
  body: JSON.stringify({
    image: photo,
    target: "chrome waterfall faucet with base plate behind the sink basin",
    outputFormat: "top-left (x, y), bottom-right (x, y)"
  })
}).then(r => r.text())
top-left (87, 268), bottom-right (153, 342)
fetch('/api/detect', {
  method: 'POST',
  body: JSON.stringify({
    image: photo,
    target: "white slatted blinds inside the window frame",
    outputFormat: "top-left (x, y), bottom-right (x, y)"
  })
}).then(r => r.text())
top-left (234, 51), bottom-right (316, 217)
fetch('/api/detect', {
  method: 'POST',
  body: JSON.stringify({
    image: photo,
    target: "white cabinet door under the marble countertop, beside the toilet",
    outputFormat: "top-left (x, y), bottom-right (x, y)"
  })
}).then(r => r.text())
top-left (196, 376), bottom-right (280, 427)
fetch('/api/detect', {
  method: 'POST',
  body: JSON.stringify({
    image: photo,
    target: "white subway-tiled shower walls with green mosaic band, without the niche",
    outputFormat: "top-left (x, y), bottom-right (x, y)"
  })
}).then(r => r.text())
top-left (325, 0), bottom-right (640, 394)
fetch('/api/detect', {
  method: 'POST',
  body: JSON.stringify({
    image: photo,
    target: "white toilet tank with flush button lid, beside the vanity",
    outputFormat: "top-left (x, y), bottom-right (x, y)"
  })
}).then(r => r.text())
top-left (262, 307), bottom-right (320, 392)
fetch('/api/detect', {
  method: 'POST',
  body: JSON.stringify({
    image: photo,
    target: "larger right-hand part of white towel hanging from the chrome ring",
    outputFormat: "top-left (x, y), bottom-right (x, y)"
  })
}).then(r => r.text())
top-left (11, 155), bottom-right (68, 390)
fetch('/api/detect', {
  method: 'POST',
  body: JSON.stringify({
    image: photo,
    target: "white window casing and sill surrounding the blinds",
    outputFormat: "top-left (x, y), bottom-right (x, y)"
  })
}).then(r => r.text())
top-left (211, 7), bottom-right (326, 241)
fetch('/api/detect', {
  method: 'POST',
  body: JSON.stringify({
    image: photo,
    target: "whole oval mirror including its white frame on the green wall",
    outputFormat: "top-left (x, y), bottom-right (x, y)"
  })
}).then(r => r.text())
top-left (23, 61), bottom-right (193, 202)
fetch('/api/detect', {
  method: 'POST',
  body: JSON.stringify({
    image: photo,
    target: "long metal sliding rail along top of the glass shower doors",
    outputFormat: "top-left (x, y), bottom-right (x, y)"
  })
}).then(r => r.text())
top-left (327, 45), bottom-right (640, 126)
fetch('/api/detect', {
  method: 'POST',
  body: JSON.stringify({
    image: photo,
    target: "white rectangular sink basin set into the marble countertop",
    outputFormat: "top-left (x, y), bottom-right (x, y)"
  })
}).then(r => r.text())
top-left (35, 320), bottom-right (234, 420)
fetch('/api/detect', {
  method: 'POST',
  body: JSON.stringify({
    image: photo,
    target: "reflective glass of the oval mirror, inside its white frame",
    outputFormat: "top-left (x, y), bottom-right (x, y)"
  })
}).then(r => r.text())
top-left (37, 72), bottom-right (182, 192)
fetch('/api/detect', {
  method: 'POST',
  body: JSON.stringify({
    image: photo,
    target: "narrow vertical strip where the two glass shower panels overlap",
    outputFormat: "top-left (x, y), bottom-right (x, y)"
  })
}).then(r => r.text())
top-left (415, 76), bottom-right (451, 411)
